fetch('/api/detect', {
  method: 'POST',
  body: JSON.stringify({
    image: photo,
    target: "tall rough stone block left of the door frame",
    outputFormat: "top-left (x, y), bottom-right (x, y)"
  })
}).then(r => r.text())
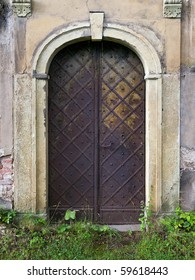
top-left (14, 74), bottom-right (32, 211)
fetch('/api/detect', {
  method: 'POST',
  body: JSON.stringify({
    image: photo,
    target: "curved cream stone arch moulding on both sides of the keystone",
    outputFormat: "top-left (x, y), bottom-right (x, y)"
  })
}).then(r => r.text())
top-left (33, 22), bottom-right (161, 75)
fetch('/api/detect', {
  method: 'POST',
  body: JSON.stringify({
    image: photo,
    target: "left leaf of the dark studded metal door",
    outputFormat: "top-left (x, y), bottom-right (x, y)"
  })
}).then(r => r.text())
top-left (48, 43), bottom-right (94, 221)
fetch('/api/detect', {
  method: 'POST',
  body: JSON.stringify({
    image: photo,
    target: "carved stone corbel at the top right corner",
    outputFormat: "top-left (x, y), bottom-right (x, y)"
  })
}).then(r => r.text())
top-left (163, 0), bottom-right (182, 18)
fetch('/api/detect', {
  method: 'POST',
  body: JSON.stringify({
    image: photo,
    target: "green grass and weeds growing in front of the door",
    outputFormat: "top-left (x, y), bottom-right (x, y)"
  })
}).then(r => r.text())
top-left (0, 219), bottom-right (195, 260)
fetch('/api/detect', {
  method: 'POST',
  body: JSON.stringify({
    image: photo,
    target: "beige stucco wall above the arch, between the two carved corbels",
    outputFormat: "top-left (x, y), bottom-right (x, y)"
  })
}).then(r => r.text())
top-left (25, 0), bottom-right (180, 72)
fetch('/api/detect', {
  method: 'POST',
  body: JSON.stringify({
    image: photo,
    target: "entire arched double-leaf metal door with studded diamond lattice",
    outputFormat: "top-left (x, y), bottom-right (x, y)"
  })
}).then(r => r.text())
top-left (48, 41), bottom-right (145, 224)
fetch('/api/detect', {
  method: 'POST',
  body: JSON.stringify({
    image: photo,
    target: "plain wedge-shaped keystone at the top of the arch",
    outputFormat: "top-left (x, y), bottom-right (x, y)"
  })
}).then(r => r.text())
top-left (90, 12), bottom-right (104, 41)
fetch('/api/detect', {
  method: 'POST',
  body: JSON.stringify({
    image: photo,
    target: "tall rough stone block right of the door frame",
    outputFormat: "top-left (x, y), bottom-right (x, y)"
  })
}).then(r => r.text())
top-left (162, 74), bottom-right (180, 212)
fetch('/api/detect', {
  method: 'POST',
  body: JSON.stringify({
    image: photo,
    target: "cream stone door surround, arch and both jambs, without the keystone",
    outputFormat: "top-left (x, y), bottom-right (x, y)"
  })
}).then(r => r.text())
top-left (31, 22), bottom-right (162, 217)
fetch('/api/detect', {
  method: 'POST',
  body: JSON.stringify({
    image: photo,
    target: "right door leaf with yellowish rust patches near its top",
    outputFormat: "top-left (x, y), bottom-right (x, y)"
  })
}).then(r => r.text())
top-left (99, 43), bottom-right (145, 224)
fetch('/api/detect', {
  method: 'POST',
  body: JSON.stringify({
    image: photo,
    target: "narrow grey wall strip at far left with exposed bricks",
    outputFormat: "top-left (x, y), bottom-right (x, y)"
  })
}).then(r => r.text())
top-left (0, 1), bottom-right (13, 208)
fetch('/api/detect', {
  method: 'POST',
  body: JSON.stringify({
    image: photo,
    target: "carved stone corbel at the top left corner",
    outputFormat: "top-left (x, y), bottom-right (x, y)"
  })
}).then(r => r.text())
top-left (12, 0), bottom-right (32, 17)
